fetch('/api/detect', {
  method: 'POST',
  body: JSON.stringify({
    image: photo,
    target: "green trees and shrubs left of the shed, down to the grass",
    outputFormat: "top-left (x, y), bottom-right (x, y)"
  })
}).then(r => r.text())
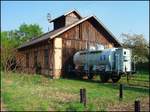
top-left (0, 24), bottom-right (42, 71)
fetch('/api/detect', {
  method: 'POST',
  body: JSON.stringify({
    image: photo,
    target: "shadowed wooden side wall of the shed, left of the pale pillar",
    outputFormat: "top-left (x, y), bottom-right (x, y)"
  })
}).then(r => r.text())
top-left (17, 40), bottom-right (54, 75)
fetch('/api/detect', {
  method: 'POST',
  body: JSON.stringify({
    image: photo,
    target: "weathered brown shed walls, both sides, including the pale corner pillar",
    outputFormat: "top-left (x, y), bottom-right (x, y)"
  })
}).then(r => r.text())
top-left (18, 15), bottom-right (118, 78)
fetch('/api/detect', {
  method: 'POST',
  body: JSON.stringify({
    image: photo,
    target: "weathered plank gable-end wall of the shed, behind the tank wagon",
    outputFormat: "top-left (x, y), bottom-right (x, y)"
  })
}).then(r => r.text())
top-left (60, 21), bottom-right (113, 73)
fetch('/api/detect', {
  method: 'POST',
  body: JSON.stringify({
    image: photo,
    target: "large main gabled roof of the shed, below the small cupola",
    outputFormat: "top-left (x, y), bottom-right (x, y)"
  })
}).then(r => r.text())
top-left (18, 15), bottom-right (122, 49)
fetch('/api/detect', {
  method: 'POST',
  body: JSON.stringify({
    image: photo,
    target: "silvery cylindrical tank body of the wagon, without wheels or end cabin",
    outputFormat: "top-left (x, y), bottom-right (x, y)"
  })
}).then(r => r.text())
top-left (73, 48), bottom-right (116, 66)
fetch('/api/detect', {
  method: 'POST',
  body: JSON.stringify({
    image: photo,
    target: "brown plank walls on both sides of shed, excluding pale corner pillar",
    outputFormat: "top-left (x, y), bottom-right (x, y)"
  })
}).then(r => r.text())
top-left (17, 18), bottom-right (113, 75)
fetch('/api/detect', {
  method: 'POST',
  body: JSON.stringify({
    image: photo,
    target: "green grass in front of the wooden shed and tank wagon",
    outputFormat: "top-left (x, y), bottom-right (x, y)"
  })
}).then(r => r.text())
top-left (1, 72), bottom-right (149, 111)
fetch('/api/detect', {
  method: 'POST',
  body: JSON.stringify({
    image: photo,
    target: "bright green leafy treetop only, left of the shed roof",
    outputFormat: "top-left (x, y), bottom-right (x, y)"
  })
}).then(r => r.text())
top-left (1, 23), bottom-right (43, 48)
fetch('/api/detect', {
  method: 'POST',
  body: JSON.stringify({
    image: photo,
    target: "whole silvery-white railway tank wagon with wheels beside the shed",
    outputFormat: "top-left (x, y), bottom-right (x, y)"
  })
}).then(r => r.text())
top-left (73, 48), bottom-right (133, 82)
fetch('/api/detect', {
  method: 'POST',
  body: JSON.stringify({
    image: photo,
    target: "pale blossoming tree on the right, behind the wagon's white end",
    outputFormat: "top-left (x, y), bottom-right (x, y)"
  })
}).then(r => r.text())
top-left (122, 33), bottom-right (149, 63)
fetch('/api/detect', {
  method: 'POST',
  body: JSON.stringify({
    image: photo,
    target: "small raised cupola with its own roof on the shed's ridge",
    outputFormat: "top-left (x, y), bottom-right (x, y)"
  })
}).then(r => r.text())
top-left (50, 10), bottom-right (82, 30)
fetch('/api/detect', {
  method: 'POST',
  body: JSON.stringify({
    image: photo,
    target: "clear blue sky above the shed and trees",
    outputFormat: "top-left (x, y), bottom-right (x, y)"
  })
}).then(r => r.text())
top-left (1, 1), bottom-right (149, 40)
